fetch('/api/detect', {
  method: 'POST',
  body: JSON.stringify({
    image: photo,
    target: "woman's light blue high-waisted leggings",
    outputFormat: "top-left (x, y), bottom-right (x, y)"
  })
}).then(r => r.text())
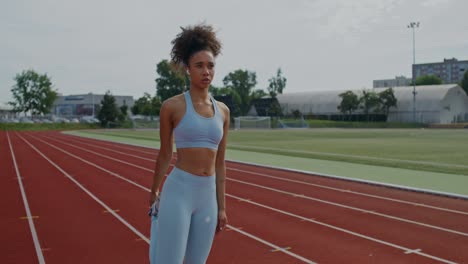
top-left (150, 167), bottom-right (218, 264)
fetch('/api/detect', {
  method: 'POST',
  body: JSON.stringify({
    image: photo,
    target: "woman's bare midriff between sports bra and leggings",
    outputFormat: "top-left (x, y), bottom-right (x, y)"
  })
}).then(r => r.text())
top-left (175, 148), bottom-right (217, 176)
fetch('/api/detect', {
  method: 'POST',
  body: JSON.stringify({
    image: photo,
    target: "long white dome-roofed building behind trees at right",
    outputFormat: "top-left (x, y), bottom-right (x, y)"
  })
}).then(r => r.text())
top-left (277, 84), bottom-right (468, 124)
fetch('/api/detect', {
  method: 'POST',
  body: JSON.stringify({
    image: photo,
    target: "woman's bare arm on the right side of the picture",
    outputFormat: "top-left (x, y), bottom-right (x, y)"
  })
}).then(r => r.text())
top-left (215, 103), bottom-right (230, 232)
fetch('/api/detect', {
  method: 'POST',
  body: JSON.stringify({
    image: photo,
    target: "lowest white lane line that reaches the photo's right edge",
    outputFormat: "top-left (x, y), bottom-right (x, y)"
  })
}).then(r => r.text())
top-left (228, 178), bottom-right (468, 236)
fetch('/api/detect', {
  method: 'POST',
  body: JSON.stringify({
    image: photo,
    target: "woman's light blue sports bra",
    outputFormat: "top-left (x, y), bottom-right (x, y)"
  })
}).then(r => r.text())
top-left (174, 91), bottom-right (224, 150)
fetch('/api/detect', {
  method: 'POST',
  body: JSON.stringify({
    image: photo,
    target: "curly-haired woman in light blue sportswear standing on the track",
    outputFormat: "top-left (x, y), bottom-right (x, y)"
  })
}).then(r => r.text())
top-left (150, 24), bottom-right (229, 264)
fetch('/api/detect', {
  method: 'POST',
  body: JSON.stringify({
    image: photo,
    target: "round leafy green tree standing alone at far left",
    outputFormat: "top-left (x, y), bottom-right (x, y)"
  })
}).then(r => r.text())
top-left (9, 70), bottom-right (57, 115)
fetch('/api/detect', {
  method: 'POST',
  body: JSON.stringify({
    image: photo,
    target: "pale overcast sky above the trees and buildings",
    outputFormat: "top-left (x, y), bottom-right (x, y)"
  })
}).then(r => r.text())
top-left (0, 0), bottom-right (468, 102)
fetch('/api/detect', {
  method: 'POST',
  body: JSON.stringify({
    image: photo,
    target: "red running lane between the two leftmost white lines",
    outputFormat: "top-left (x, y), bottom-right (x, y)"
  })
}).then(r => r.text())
top-left (11, 134), bottom-right (148, 263)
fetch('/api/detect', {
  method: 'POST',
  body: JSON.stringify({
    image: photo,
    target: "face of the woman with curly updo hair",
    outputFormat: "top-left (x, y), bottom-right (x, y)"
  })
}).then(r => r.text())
top-left (187, 50), bottom-right (215, 88)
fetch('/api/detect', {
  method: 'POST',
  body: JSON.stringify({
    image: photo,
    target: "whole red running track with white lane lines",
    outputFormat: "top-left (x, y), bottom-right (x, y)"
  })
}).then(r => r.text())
top-left (0, 132), bottom-right (468, 263)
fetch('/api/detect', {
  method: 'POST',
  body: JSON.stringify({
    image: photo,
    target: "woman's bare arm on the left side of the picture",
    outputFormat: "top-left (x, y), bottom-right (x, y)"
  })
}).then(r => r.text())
top-left (149, 99), bottom-right (174, 206)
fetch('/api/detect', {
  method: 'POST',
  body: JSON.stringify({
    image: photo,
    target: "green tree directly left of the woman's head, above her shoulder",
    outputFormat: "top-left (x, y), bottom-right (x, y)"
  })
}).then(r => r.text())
top-left (155, 60), bottom-right (186, 101)
